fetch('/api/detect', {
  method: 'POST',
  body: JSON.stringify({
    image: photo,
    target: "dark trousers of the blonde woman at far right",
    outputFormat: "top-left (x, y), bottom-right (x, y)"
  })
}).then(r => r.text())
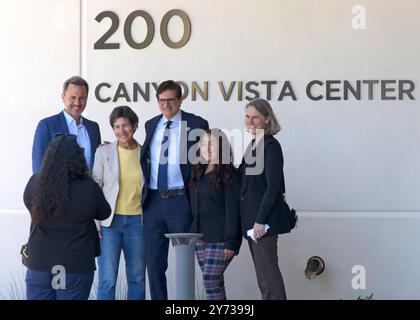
top-left (248, 235), bottom-right (287, 300)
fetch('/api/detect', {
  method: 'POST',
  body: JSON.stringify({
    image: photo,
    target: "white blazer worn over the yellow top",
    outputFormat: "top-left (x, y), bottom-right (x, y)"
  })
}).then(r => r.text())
top-left (92, 141), bottom-right (144, 230)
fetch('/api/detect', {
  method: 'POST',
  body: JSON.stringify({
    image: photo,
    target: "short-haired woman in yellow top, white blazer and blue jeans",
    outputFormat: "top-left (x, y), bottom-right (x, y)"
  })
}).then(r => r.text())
top-left (92, 106), bottom-right (146, 300)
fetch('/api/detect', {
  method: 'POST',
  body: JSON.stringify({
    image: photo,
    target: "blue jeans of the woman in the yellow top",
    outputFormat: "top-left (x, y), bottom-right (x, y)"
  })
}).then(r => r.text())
top-left (97, 214), bottom-right (146, 300)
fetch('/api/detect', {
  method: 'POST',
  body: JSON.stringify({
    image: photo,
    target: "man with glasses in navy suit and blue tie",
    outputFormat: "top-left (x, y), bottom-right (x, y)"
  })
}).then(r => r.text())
top-left (141, 80), bottom-right (209, 300)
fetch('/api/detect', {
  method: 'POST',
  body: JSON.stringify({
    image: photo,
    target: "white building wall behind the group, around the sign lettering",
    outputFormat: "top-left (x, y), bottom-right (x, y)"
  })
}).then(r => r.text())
top-left (0, 0), bottom-right (420, 299)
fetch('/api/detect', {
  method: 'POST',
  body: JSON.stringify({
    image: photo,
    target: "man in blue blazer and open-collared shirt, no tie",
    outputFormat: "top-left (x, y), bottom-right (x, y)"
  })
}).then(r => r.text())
top-left (32, 76), bottom-right (101, 173)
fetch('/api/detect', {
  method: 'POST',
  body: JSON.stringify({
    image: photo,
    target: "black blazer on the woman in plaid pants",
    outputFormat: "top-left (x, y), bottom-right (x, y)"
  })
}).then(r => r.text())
top-left (189, 167), bottom-right (242, 254)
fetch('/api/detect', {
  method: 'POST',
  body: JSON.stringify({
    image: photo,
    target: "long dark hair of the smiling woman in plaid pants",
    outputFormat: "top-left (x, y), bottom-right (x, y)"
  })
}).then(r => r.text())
top-left (189, 128), bottom-right (235, 191)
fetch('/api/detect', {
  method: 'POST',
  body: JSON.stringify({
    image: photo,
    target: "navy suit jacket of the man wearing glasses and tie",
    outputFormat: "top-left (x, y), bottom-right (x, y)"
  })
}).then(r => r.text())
top-left (140, 110), bottom-right (209, 208)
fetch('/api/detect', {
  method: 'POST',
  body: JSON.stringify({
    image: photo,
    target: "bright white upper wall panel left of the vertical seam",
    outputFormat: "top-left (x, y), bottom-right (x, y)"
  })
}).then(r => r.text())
top-left (0, 0), bottom-right (80, 211)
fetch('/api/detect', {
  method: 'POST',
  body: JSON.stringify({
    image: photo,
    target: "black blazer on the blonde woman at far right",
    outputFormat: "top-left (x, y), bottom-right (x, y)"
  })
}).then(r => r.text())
top-left (240, 135), bottom-right (290, 237)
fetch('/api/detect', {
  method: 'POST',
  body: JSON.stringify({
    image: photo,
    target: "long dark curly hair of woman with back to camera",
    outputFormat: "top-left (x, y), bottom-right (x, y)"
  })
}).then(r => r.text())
top-left (32, 135), bottom-right (89, 222)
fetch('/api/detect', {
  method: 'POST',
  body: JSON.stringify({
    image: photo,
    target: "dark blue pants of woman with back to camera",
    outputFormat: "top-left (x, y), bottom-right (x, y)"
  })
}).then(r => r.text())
top-left (25, 268), bottom-right (94, 300)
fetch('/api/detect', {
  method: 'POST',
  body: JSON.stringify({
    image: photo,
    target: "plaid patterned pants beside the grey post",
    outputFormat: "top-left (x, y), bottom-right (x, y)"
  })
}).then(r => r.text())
top-left (195, 240), bottom-right (232, 300)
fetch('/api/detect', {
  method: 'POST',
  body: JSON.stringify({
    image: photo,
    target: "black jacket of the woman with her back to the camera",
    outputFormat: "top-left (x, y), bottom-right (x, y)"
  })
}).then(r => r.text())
top-left (23, 174), bottom-right (111, 272)
